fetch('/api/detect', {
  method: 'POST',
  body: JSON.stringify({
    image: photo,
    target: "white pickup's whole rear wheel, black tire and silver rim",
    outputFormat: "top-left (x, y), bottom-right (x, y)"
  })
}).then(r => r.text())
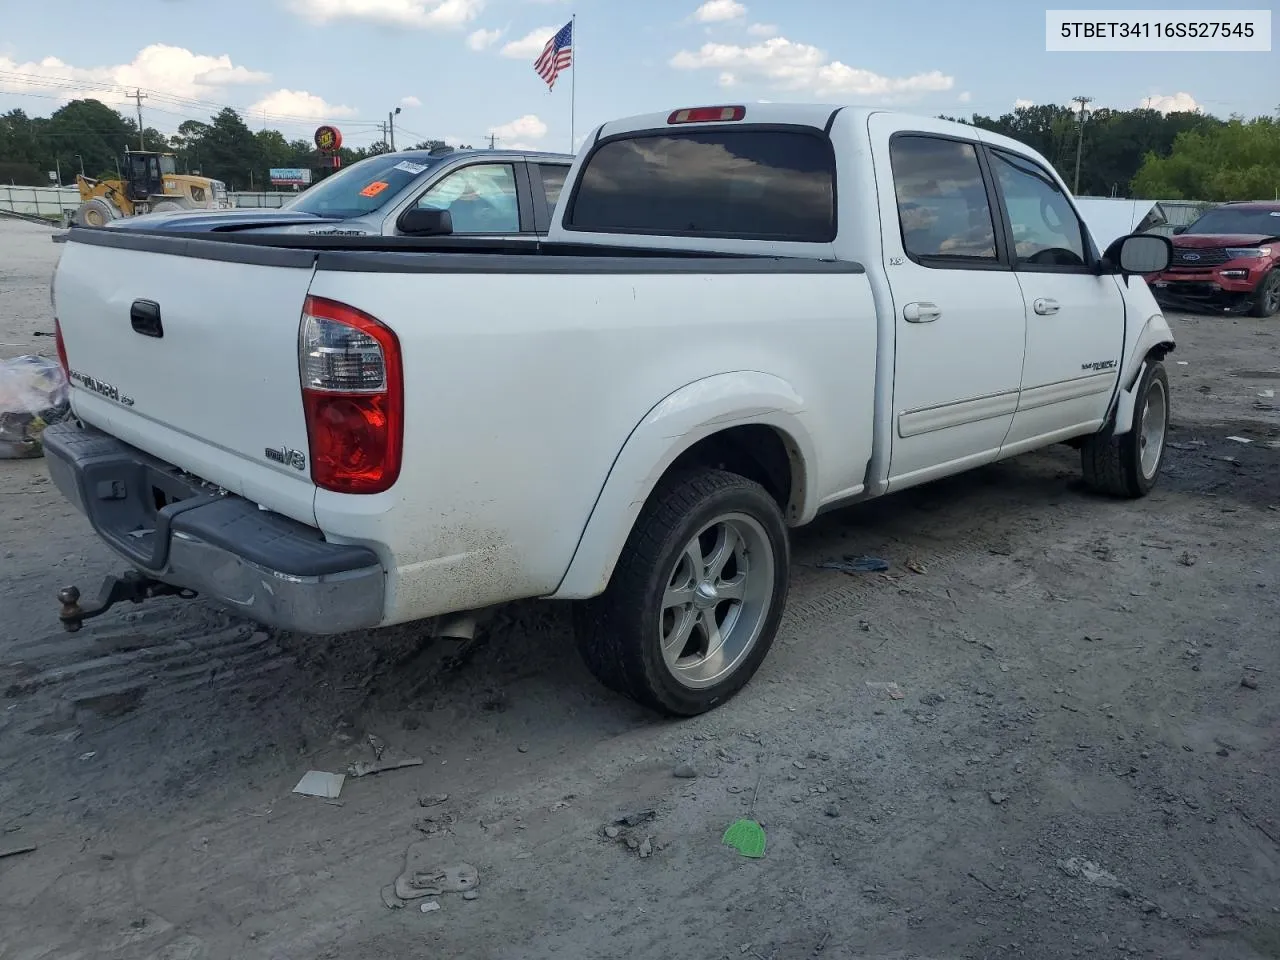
top-left (575, 468), bottom-right (791, 717)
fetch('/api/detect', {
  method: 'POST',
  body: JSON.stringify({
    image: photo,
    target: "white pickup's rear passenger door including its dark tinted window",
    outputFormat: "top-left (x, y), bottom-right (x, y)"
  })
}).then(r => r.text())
top-left (869, 114), bottom-right (1027, 489)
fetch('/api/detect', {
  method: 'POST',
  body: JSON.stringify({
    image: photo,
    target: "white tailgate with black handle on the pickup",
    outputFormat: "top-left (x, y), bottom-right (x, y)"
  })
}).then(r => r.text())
top-left (54, 238), bottom-right (315, 524)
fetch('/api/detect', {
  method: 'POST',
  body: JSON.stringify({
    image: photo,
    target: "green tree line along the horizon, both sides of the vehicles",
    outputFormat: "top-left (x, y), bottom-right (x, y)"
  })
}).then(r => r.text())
top-left (0, 100), bottom-right (1280, 201)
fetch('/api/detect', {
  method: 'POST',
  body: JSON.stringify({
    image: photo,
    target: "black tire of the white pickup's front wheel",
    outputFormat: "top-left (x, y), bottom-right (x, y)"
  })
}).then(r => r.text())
top-left (1080, 360), bottom-right (1169, 499)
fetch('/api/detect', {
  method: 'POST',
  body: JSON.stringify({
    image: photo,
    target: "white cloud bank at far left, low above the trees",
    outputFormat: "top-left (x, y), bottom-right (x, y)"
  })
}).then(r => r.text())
top-left (0, 44), bottom-right (271, 104)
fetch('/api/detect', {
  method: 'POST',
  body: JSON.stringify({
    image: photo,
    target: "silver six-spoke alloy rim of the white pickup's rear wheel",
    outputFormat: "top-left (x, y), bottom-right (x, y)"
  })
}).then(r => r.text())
top-left (658, 513), bottom-right (776, 689)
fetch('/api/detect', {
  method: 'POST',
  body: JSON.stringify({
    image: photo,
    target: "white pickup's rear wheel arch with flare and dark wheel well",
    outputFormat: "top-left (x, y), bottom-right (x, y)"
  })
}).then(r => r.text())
top-left (550, 371), bottom-right (817, 599)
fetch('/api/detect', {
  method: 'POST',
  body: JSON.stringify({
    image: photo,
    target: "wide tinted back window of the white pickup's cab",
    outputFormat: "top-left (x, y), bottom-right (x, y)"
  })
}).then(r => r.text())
top-left (566, 128), bottom-right (836, 243)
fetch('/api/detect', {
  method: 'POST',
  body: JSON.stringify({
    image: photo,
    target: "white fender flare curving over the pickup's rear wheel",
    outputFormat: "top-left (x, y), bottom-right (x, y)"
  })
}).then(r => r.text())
top-left (549, 370), bottom-right (817, 600)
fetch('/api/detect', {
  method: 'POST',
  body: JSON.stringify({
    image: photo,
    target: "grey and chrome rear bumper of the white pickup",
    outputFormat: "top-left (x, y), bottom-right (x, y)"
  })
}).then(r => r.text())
top-left (42, 422), bottom-right (387, 635)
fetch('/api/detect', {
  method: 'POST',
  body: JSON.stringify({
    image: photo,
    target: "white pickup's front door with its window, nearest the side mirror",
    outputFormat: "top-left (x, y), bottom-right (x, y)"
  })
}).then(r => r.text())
top-left (989, 147), bottom-right (1126, 456)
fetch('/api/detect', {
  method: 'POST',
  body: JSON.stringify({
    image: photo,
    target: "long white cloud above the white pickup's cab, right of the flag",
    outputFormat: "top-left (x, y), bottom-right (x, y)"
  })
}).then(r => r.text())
top-left (671, 37), bottom-right (955, 101)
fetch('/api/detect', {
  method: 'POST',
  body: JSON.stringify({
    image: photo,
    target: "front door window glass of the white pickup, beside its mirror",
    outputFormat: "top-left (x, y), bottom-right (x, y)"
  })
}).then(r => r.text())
top-left (992, 150), bottom-right (1088, 266)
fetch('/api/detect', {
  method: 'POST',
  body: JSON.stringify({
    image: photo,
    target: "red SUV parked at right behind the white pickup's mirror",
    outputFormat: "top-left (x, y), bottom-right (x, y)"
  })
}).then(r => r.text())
top-left (1147, 201), bottom-right (1280, 317)
